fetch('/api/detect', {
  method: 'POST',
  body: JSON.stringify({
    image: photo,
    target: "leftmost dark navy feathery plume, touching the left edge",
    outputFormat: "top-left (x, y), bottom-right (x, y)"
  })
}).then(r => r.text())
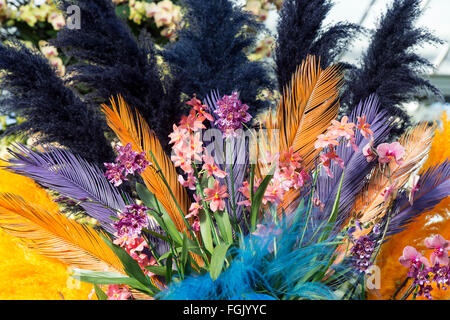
top-left (0, 43), bottom-right (113, 164)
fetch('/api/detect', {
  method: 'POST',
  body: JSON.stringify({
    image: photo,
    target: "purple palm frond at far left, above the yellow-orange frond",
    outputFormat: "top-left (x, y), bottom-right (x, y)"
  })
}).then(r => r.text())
top-left (7, 144), bottom-right (125, 233)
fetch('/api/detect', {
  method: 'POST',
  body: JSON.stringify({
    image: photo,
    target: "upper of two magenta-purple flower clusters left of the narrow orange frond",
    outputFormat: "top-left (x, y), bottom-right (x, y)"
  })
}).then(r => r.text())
top-left (104, 143), bottom-right (149, 187)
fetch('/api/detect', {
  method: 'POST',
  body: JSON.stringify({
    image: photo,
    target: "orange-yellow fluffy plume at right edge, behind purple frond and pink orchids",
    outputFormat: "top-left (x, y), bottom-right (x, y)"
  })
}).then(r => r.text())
top-left (368, 113), bottom-right (450, 300)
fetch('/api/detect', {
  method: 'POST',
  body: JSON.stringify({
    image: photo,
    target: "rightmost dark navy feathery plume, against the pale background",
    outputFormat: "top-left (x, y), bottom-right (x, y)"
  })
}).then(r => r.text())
top-left (341, 0), bottom-right (440, 135)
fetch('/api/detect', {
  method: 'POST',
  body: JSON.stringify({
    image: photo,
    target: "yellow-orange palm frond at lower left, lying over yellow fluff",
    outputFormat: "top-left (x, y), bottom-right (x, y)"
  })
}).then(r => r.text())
top-left (0, 194), bottom-right (123, 274)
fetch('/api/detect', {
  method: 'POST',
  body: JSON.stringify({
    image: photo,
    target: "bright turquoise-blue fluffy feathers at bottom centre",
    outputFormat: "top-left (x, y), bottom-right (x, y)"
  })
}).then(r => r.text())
top-left (158, 206), bottom-right (348, 300)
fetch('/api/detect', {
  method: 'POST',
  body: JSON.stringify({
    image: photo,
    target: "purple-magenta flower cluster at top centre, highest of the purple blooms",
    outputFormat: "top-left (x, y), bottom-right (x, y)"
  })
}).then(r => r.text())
top-left (214, 92), bottom-right (252, 137)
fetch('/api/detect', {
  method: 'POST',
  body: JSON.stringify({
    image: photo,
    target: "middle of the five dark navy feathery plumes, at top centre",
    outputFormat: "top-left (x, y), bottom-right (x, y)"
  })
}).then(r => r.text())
top-left (163, 0), bottom-right (272, 113)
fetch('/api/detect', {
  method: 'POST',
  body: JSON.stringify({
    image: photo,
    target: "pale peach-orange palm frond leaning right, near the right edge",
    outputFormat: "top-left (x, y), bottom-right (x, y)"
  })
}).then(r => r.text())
top-left (353, 123), bottom-right (435, 223)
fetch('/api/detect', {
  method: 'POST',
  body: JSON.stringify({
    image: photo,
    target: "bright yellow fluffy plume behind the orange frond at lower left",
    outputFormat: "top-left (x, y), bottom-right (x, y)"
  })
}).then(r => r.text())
top-left (0, 161), bottom-right (95, 300)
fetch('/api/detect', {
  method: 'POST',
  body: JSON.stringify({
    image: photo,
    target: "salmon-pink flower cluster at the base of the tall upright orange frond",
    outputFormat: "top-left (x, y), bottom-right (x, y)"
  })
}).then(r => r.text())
top-left (238, 147), bottom-right (309, 207)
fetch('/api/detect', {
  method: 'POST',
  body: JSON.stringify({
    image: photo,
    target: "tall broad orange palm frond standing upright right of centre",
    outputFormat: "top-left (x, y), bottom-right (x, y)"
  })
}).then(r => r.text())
top-left (258, 56), bottom-right (343, 211)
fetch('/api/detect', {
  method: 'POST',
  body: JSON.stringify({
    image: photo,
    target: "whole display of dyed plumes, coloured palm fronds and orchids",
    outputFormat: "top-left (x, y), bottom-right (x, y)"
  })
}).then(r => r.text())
top-left (0, 0), bottom-right (450, 300)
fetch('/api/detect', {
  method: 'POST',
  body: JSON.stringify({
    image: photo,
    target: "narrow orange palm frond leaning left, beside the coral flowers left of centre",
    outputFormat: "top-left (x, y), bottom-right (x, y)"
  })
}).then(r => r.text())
top-left (102, 96), bottom-right (190, 231)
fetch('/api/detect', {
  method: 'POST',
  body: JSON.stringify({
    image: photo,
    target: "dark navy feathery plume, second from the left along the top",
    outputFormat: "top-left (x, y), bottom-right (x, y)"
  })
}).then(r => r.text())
top-left (53, 0), bottom-right (182, 146)
